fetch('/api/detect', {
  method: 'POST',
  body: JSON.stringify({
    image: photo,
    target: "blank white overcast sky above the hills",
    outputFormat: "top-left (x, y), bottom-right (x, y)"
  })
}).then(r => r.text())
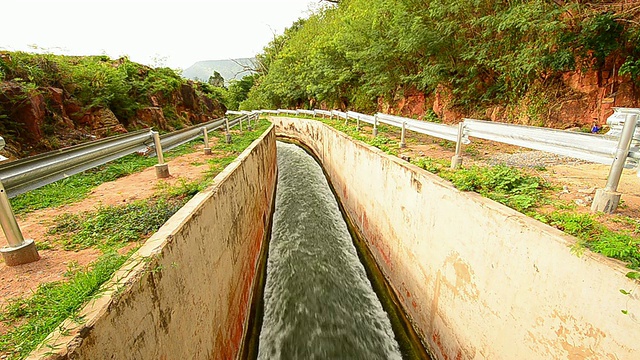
top-left (0, 0), bottom-right (319, 69)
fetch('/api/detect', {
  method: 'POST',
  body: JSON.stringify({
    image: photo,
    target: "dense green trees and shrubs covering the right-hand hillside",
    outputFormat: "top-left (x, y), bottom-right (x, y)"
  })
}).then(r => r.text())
top-left (242, 0), bottom-right (640, 121)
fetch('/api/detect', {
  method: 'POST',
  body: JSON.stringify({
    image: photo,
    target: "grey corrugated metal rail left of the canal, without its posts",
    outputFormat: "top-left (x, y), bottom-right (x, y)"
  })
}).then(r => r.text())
top-left (0, 119), bottom-right (230, 198)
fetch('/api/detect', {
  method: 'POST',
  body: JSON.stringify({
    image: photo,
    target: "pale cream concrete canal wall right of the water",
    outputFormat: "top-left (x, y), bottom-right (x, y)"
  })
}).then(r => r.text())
top-left (272, 117), bottom-right (640, 359)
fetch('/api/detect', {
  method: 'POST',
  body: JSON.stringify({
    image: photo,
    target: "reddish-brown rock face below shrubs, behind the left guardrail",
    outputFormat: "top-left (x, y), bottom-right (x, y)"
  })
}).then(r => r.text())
top-left (0, 81), bottom-right (226, 157)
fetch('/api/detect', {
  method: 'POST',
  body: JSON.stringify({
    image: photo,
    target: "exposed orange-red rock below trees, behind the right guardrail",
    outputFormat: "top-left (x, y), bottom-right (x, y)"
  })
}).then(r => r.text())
top-left (378, 67), bottom-right (640, 129)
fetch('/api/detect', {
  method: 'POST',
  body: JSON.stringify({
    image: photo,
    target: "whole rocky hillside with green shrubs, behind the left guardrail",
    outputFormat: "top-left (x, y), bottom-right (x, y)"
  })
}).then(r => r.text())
top-left (0, 52), bottom-right (226, 158)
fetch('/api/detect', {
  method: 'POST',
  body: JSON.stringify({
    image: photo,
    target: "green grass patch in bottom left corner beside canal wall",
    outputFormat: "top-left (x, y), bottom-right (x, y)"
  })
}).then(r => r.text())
top-left (0, 252), bottom-right (128, 359)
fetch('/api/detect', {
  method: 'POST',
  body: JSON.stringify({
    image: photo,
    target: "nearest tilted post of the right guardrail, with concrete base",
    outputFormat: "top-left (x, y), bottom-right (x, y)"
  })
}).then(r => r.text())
top-left (591, 113), bottom-right (639, 214)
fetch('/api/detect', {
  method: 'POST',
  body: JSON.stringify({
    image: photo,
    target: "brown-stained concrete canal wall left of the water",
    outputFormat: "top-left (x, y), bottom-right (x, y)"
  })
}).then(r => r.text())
top-left (30, 127), bottom-right (276, 360)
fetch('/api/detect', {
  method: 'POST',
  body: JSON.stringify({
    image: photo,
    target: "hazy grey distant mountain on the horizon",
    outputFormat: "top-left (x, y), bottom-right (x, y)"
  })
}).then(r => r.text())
top-left (182, 58), bottom-right (255, 84)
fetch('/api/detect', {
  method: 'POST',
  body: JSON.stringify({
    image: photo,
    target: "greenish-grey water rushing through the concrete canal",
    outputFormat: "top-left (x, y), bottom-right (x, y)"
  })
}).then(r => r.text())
top-left (258, 143), bottom-right (402, 359)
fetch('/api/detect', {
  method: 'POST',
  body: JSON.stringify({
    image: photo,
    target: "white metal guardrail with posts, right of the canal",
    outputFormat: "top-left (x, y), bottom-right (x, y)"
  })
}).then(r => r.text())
top-left (262, 108), bottom-right (640, 213)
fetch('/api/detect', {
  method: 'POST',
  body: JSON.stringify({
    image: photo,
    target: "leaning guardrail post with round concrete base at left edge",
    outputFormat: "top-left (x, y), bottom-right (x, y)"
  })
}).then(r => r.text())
top-left (0, 182), bottom-right (40, 266)
